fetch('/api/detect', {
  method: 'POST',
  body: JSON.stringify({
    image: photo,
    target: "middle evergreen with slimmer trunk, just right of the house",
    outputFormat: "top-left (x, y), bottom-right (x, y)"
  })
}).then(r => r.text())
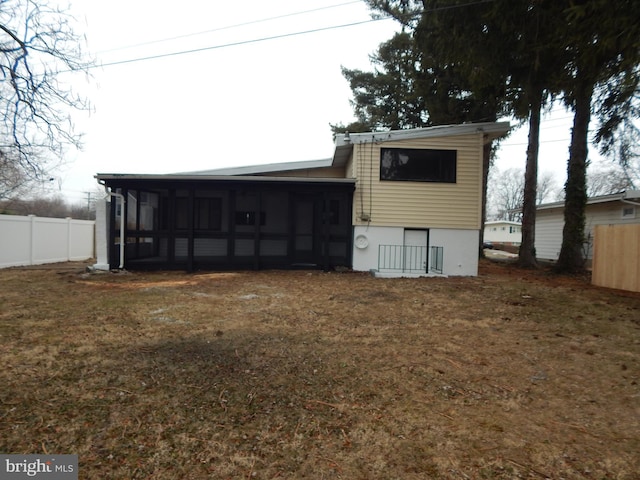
top-left (360, 0), bottom-right (558, 266)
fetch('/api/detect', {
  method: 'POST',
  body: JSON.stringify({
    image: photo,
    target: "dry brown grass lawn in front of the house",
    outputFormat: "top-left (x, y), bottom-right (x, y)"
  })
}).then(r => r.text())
top-left (0, 263), bottom-right (640, 479)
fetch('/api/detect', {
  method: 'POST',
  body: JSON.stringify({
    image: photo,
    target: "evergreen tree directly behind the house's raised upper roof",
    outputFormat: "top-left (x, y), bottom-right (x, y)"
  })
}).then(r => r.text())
top-left (332, 1), bottom-right (510, 255)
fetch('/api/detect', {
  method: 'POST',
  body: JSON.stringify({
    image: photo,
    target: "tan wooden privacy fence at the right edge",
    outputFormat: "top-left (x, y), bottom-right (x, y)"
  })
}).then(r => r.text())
top-left (591, 224), bottom-right (640, 292)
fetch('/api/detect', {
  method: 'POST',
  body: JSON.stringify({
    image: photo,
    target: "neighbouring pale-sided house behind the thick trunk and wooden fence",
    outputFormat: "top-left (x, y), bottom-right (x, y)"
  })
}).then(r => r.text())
top-left (535, 190), bottom-right (640, 261)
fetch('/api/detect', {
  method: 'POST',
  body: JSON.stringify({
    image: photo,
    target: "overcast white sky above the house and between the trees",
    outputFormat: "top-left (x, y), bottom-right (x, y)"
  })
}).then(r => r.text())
top-left (47, 0), bottom-right (604, 201)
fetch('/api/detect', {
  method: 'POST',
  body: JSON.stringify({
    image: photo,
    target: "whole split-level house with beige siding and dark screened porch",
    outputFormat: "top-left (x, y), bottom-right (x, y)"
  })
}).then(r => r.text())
top-left (96, 122), bottom-right (509, 276)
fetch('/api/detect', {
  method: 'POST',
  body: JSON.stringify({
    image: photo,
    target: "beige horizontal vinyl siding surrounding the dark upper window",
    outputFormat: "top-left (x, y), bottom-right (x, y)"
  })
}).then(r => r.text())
top-left (353, 134), bottom-right (482, 229)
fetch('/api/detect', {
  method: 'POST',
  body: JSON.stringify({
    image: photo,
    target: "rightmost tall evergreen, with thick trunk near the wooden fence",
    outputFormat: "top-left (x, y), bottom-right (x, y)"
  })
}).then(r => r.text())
top-left (556, 0), bottom-right (640, 273)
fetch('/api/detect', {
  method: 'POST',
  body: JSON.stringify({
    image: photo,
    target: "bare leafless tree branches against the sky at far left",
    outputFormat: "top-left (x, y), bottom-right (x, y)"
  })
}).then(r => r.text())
top-left (0, 0), bottom-right (92, 196)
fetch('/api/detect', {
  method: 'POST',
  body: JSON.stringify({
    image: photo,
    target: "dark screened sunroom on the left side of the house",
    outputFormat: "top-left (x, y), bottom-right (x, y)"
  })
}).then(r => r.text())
top-left (96, 174), bottom-right (354, 271)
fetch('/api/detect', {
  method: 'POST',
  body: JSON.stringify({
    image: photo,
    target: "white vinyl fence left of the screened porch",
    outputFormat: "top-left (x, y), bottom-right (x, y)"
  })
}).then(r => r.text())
top-left (0, 215), bottom-right (95, 268)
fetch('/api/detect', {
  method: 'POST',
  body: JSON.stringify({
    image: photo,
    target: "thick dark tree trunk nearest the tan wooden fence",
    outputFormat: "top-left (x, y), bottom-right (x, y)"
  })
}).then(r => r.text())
top-left (556, 82), bottom-right (593, 273)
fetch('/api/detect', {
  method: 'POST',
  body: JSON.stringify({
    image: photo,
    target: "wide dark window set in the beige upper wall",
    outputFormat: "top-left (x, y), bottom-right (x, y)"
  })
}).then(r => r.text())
top-left (380, 148), bottom-right (457, 183)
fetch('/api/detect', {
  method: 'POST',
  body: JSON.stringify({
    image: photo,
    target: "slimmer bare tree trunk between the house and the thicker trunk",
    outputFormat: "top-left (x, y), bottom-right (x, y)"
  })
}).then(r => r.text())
top-left (518, 91), bottom-right (542, 268)
